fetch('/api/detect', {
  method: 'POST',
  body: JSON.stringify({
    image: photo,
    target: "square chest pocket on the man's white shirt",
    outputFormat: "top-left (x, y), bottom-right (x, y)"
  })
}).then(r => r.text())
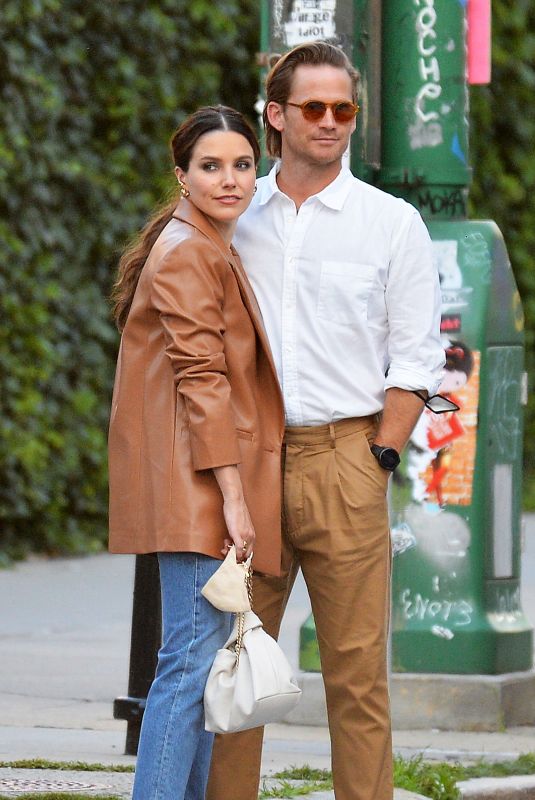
top-left (317, 261), bottom-right (376, 325)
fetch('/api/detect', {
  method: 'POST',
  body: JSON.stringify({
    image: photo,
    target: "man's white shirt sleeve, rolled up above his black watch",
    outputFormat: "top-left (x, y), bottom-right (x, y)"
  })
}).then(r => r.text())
top-left (385, 210), bottom-right (445, 394)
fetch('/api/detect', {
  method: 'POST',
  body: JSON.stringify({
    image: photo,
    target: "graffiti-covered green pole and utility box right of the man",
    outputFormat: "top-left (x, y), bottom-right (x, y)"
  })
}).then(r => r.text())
top-left (378, 0), bottom-right (533, 674)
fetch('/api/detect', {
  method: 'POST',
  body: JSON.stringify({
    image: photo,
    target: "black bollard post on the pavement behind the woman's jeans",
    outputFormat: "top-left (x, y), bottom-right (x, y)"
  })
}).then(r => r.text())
top-left (113, 553), bottom-right (162, 756)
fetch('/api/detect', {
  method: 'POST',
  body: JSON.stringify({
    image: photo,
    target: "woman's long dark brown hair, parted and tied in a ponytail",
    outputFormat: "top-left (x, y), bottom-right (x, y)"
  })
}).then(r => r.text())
top-left (111, 106), bottom-right (260, 331)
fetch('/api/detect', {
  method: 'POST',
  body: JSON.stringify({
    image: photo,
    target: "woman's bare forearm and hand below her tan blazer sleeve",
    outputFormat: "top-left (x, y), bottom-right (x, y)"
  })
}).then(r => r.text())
top-left (214, 465), bottom-right (255, 561)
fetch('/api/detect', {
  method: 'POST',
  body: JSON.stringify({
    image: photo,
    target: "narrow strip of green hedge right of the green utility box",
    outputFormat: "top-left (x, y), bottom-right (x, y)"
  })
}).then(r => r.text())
top-left (470, 0), bottom-right (535, 510)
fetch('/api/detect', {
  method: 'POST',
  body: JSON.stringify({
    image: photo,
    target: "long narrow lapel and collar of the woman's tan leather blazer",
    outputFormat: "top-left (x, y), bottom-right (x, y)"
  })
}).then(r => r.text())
top-left (173, 197), bottom-right (278, 385)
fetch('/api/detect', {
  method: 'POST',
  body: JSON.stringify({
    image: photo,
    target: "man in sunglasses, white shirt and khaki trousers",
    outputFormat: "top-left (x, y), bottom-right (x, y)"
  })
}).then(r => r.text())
top-left (207, 42), bottom-right (444, 800)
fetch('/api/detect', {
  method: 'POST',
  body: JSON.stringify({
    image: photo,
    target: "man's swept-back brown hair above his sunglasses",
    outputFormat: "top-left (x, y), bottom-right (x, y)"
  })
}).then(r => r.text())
top-left (262, 42), bottom-right (359, 158)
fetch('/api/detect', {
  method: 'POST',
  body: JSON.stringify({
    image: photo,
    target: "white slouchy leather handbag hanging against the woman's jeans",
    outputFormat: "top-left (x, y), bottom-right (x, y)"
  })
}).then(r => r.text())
top-left (204, 611), bottom-right (301, 733)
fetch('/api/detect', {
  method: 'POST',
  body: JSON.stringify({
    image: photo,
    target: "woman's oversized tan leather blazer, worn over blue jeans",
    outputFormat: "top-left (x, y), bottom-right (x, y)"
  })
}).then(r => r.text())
top-left (109, 200), bottom-right (284, 575)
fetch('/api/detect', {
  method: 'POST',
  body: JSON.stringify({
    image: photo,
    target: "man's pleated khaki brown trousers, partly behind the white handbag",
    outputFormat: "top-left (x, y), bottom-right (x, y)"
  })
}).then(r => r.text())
top-left (206, 417), bottom-right (393, 800)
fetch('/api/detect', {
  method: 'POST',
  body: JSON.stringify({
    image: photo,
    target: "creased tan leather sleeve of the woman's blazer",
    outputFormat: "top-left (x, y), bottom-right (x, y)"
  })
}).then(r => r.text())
top-left (151, 234), bottom-right (240, 470)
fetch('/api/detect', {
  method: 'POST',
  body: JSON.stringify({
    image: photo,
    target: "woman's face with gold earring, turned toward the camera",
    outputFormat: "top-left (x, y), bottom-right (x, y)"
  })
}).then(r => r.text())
top-left (175, 131), bottom-right (256, 242)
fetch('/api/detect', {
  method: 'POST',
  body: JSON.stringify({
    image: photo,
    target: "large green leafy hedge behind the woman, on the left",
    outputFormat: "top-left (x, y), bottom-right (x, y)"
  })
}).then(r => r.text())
top-left (0, 0), bottom-right (258, 555)
